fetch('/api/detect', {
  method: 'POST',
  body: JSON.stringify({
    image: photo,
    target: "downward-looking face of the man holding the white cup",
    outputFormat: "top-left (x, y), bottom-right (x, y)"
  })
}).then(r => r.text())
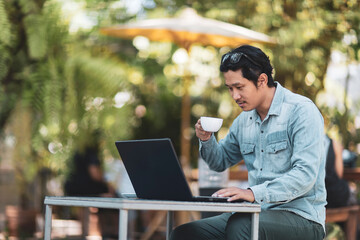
top-left (224, 70), bottom-right (263, 111)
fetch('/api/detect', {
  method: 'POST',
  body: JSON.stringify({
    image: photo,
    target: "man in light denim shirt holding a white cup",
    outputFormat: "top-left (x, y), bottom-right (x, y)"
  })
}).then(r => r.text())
top-left (171, 45), bottom-right (326, 240)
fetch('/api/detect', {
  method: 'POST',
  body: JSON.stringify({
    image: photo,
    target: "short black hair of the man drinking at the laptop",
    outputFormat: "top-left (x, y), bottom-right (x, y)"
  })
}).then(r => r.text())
top-left (220, 45), bottom-right (275, 87)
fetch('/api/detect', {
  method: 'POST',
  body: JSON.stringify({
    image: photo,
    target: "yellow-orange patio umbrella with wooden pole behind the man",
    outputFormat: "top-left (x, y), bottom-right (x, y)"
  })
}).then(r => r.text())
top-left (100, 8), bottom-right (275, 176)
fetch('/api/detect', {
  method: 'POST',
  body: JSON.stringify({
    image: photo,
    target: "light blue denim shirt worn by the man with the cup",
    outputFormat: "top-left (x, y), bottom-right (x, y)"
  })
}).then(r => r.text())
top-left (200, 83), bottom-right (326, 229)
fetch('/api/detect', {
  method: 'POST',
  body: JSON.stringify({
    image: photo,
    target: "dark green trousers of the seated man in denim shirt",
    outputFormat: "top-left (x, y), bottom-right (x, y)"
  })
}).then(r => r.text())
top-left (170, 210), bottom-right (325, 240)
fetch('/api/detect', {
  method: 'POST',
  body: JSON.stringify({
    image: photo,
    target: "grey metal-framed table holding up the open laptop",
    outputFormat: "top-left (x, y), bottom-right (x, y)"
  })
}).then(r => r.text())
top-left (44, 196), bottom-right (261, 240)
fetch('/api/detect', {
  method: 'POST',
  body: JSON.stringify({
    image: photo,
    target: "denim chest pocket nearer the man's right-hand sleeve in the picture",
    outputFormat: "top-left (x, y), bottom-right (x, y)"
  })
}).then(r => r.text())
top-left (265, 139), bottom-right (291, 173)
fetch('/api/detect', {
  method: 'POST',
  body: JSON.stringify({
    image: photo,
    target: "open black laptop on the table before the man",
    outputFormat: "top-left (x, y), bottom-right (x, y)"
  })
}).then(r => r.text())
top-left (115, 138), bottom-right (239, 202)
